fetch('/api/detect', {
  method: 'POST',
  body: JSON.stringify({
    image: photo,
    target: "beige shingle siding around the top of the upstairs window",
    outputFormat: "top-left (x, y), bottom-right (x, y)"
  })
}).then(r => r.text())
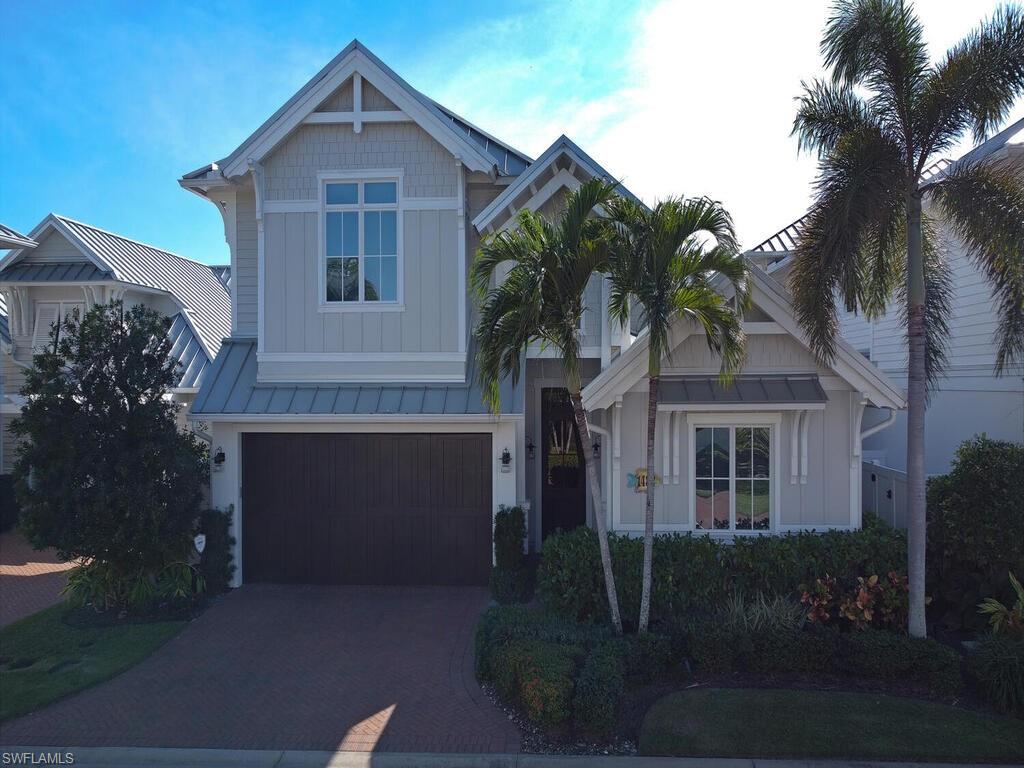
top-left (264, 123), bottom-right (458, 200)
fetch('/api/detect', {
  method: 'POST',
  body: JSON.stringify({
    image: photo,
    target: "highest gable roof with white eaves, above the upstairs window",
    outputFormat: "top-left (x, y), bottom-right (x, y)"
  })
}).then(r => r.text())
top-left (182, 40), bottom-right (530, 180)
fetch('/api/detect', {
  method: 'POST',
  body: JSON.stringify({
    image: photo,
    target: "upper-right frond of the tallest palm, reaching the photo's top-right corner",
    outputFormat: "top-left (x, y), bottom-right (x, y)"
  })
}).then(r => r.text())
top-left (915, 5), bottom-right (1024, 157)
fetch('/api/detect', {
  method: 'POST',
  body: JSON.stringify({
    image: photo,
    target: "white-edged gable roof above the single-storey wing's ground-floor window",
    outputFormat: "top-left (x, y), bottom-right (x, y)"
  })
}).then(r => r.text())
top-left (583, 266), bottom-right (906, 411)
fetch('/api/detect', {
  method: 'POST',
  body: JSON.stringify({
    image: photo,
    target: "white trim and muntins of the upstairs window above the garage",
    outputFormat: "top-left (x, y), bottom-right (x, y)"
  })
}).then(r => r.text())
top-left (316, 168), bottom-right (406, 312)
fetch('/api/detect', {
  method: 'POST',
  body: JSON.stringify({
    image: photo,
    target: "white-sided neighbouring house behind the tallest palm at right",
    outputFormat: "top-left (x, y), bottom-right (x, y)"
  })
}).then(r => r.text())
top-left (748, 120), bottom-right (1024, 481)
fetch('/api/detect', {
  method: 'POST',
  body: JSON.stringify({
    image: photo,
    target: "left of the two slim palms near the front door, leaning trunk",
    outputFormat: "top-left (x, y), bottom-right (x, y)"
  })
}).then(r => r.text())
top-left (470, 179), bottom-right (623, 633)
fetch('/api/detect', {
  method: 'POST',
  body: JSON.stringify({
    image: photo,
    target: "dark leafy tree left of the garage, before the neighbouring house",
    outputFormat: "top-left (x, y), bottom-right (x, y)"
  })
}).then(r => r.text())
top-left (10, 301), bottom-right (207, 609)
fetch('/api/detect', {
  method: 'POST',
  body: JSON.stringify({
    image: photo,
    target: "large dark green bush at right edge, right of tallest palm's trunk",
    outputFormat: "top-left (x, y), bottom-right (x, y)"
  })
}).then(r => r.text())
top-left (927, 437), bottom-right (1024, 631)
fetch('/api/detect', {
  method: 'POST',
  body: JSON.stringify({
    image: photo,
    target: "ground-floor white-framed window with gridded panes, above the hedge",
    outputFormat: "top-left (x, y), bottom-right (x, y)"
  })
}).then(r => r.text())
top-left (693, 425), bottom-right (772, 530)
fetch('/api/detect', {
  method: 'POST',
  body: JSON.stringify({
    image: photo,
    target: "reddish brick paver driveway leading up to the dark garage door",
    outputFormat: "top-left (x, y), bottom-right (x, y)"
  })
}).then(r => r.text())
top-left (0, 585), bottom-right (519, 752)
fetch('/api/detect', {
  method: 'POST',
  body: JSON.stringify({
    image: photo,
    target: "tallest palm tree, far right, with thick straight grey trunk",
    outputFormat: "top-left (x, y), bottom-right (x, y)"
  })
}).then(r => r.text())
top-left (791, 0), bottom-right (1024, 636)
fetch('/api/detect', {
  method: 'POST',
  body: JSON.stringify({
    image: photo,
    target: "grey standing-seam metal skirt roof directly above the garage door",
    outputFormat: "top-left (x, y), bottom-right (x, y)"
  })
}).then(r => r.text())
top-left (189, 339), bottom-right (523, 420)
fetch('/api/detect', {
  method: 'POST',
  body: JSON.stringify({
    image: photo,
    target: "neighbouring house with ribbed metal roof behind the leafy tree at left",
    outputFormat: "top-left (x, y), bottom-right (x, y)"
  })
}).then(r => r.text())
top-left (0, 213), bottom-right (231, 474)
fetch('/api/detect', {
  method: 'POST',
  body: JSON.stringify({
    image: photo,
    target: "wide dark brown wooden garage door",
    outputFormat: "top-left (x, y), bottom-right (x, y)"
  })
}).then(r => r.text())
top-left (242, 433), bottom-right (490, 585)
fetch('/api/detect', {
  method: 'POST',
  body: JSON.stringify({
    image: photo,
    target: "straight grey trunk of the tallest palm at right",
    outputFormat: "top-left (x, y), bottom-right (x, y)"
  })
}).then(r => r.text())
top-left (906, 190), bottom-right (928, 637)
